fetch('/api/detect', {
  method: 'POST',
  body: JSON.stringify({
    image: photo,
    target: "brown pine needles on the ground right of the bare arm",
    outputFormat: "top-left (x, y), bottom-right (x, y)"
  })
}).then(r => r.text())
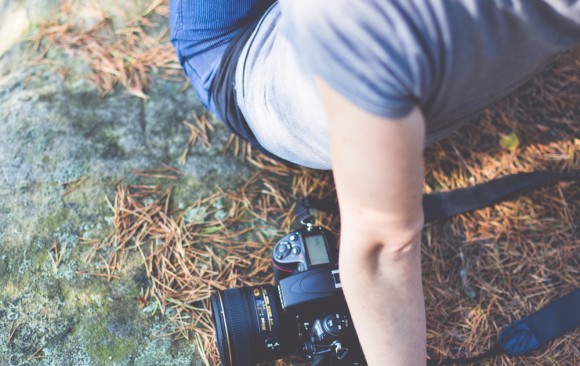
top-left (423, 53), bottom-right (580, 365)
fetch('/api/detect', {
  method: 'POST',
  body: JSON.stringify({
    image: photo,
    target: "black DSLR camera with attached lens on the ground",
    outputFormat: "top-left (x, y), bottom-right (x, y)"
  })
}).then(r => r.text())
top-left (211, 222), bottom-right (366, 366)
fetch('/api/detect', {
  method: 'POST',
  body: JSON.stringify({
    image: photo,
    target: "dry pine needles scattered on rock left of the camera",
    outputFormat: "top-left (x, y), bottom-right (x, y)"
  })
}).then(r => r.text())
top-left (82, 158), bottom-right (336, 365)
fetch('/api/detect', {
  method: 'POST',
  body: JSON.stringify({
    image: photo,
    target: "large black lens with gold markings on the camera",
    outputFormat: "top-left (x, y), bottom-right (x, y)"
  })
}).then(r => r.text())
top-left (211, 285), bottom-right (297, 366)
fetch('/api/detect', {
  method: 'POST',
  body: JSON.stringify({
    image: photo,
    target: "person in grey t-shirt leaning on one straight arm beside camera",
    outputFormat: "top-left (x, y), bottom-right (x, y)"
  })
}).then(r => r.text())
top-left (170, 0), bottom-right (580, 365)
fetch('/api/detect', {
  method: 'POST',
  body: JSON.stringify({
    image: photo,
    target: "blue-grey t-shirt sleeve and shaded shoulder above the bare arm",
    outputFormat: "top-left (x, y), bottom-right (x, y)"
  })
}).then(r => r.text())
top-left (280, 0), bottom-right (580, 123)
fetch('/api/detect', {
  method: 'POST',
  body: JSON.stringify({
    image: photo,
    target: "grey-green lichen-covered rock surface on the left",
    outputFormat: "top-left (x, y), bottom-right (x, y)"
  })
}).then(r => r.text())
top-left (0, 15), bottom-right (251, 366)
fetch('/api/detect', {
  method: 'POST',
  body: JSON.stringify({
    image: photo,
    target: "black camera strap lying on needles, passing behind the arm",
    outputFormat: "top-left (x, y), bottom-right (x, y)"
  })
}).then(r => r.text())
top-left (296, 172), bottom-right (580, 366)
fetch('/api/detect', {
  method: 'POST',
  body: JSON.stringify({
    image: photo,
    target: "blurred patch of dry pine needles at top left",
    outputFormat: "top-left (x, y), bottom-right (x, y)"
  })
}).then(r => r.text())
top-left (32, 0), bottom-right (183, 99)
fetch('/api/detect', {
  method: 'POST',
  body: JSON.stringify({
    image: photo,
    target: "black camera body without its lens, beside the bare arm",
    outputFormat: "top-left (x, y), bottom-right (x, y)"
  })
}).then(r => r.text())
top-left (272, 225), bottom-right (364, 365)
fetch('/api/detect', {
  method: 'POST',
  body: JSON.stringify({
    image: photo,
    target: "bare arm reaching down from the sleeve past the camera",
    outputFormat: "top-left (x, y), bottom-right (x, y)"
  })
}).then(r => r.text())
top-left (319, 81), bottom-right (426, 365)
